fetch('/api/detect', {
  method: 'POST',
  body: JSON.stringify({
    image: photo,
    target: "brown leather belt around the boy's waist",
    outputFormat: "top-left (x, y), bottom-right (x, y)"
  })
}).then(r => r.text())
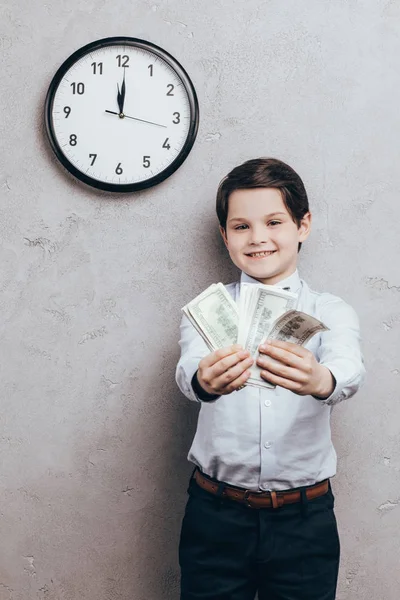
top-left (193, 469), bottom-right (329, 508)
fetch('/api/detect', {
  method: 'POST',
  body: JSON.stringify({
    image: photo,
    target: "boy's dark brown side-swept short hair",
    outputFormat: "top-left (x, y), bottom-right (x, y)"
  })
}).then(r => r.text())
top-left (217, 158), bottom-right (309, 250)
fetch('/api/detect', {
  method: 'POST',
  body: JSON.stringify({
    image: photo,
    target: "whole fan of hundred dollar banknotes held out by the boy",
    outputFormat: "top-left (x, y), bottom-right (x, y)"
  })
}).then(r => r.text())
top-left (182, 283), bottom-right (329, 388)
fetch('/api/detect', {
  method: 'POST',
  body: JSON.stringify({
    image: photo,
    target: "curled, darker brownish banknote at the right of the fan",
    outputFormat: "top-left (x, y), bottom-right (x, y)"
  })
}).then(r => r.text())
top-left (268, 310), bottom-right (329, 346)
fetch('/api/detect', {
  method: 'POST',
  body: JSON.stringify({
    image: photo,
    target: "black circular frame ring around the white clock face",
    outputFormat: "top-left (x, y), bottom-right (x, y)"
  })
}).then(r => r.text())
top-left (44, 36), bottom-right (200, 193)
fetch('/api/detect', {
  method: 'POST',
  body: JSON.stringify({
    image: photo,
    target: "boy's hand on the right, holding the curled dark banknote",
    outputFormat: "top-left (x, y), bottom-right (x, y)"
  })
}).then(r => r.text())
top-left (257, 340), bottom-right (336, 399)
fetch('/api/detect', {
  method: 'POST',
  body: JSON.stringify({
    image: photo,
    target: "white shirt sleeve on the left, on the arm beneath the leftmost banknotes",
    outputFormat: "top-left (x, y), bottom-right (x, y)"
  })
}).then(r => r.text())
top-left (175, 315), bottom-right (219, 402)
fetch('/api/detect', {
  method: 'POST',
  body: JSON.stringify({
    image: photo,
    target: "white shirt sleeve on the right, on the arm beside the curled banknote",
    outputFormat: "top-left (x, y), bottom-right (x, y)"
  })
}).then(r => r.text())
top-left (317, 296), bottom-right (365, 405)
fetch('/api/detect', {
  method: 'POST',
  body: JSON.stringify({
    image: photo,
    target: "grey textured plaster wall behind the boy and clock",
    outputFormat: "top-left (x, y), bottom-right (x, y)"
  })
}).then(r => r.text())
top-left (0, 0), bottom-right (400, 600)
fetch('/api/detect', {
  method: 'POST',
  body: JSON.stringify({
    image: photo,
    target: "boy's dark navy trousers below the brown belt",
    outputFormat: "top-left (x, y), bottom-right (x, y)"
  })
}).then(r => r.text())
top-left (179, 479), bottom-right (340, 600)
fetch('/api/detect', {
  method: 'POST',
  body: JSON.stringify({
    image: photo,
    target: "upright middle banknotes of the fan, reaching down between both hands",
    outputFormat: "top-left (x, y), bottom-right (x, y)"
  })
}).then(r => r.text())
top-left (238, 283), bottom-right (297, 388)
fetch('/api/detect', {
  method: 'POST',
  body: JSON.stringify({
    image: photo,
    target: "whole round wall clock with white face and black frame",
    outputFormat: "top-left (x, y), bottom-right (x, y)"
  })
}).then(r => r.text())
top-left (45, 37), bottom-right (199, 192)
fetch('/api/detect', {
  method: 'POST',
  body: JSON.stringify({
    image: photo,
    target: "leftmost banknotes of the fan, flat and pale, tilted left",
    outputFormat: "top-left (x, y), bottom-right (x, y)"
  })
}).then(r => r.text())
top-left (182, 283), bottom-right (239, 351)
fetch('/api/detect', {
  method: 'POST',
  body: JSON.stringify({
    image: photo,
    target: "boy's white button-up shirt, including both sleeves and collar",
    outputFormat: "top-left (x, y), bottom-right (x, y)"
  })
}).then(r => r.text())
top-left (176, 271), bottom-right (365, 491)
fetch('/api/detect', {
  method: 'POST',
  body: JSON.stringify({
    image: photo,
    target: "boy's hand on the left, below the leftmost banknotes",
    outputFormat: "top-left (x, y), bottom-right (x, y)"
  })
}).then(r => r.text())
top-left (197, 344), bottom-right (254, 396)
